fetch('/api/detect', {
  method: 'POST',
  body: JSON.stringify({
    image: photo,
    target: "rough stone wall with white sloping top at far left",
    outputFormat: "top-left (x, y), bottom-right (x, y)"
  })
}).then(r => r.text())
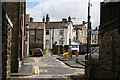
top-left (2, 9), bottom-right (12, 80)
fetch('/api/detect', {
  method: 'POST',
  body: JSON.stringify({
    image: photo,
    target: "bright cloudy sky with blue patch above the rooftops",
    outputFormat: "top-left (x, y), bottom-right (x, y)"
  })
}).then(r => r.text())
top-left (26, 0), bottom-right (104, 28)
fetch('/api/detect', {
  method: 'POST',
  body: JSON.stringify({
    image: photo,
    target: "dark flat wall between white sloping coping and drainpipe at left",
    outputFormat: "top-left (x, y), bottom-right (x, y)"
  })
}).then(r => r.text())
top-left (4, 2), bottom-right (20, 72)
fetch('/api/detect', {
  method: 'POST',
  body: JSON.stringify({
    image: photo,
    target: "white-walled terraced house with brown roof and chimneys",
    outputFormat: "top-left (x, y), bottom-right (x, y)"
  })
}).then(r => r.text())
top-left (45, 15), bottom-right (74, 53)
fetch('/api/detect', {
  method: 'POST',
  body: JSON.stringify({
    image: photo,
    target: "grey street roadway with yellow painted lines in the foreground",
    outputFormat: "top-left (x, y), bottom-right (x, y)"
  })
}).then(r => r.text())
top-left (11, 54), bottom-right (84, 80)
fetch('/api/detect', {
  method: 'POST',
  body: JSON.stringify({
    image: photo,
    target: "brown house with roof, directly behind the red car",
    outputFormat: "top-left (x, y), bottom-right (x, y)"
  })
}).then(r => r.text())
top-left (28, 22), bottom-right (45, 49)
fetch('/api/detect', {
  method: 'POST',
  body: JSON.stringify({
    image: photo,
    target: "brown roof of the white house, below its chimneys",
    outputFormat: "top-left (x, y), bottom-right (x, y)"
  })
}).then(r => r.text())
top-left (45, 21), bottom-right (70, 29)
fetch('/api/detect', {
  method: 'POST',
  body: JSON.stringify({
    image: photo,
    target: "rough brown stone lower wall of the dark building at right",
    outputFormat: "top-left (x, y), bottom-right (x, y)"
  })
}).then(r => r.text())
top-left (100, 29), bottom-right (120, 79)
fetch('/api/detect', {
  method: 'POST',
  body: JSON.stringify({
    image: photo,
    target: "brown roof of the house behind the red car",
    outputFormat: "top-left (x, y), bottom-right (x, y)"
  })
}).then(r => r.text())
top-left (29, 22), bottom-right (45, 29)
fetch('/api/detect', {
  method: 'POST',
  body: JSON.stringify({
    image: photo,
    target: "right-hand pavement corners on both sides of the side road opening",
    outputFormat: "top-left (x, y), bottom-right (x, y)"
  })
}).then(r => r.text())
top-left (52, 55), bottom-right (89, 80)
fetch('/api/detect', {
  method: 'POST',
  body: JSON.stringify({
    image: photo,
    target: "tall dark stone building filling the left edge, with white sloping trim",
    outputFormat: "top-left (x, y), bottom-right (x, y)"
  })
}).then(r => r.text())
top-left (1, 2), bottom-right (25, 80)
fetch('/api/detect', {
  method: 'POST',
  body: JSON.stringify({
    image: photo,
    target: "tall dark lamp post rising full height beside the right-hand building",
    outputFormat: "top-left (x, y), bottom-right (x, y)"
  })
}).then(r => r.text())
top-left (87, 0), bottom-right (91, 79)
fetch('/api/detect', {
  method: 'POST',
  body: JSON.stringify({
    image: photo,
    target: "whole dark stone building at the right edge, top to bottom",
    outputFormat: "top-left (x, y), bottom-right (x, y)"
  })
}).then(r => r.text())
top-left (99, 2), bottom-right (120, 80)
